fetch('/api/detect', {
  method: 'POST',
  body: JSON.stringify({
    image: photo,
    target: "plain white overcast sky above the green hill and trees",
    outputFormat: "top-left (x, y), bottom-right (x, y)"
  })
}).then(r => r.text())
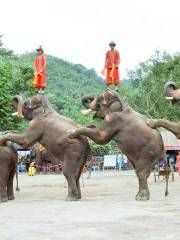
top-left (0, 0), bottom-right (180, 78)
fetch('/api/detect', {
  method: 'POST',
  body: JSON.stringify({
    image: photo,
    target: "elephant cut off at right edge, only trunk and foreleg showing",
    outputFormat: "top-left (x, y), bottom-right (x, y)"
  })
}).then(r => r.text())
top-left (147, 82), bottom-right (180, 139)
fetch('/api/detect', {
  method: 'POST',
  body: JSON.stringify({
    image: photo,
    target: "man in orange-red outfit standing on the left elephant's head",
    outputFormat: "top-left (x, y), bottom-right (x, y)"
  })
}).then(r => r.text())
top-left (33, 46), bottom-right (46, 94)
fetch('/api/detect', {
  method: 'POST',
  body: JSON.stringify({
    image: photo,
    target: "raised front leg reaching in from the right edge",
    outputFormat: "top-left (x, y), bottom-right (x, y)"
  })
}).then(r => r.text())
top-left (147, 119), bottom-right (180, 139)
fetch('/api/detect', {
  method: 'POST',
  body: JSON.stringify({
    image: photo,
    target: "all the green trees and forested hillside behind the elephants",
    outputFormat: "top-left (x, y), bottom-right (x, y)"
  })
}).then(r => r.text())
top-left (0, 36), bottom-right (180, 131)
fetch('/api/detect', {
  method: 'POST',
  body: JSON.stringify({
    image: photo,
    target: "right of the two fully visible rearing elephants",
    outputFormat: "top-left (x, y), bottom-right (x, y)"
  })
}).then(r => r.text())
top-left (68, 89), bottom-right (168, 200)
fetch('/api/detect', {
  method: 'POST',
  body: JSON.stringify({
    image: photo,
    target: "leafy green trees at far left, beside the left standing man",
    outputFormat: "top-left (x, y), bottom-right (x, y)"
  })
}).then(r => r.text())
top-left (0, 37), bottom-right (32, 131)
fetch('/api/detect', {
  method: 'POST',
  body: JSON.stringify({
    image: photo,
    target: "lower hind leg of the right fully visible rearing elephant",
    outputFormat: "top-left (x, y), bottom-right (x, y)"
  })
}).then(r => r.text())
top-left (135, 160), bottom-right (151, 201)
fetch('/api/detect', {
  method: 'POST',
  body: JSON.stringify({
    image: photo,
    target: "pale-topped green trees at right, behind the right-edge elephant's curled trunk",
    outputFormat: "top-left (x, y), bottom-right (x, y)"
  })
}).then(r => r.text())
top-left (124, 51), bottom-right (180, 121)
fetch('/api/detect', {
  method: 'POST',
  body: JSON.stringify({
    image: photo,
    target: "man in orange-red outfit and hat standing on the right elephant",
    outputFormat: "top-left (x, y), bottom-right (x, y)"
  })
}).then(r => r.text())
top-left (104, 41), bottom-right (120, 91)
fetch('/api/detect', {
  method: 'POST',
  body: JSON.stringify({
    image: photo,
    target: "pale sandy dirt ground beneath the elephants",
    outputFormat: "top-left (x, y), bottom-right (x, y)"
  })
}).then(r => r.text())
top-left (0, 171), bottom-right (180, 240)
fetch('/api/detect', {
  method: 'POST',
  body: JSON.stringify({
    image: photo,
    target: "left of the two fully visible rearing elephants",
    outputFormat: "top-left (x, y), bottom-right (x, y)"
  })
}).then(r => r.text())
top-left (0, 94), bottom-right (91, 201)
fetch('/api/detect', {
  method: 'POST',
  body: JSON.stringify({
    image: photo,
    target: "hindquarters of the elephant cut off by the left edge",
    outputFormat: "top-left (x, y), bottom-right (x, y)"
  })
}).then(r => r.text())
top-left (0, 142), bottom-right (19, 202)
